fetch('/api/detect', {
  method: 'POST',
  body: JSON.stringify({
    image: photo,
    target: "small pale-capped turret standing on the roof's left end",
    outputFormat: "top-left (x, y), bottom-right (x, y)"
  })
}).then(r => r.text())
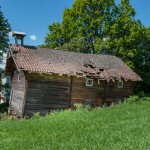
top-left (12, 31), bottom-right (26, 45)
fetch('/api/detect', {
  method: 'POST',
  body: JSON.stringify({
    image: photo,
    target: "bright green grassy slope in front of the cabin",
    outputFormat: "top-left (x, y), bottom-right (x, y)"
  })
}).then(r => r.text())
top-left (0, 102), bottom-right (150, 150)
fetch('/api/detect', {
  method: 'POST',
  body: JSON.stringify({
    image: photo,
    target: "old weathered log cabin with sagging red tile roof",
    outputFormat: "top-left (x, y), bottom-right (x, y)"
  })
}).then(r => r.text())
top-left (5, 33), bottom-right (141, 117)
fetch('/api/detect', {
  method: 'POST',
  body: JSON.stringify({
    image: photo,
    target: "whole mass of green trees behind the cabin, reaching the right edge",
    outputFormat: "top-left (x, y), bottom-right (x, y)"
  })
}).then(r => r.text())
top-left (43, 0), bottom-right (150, 91)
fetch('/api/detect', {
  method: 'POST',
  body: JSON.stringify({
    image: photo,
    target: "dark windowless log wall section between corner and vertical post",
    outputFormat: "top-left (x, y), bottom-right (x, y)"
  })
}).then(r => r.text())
top-left (25, 73), bottom-right (70, 116)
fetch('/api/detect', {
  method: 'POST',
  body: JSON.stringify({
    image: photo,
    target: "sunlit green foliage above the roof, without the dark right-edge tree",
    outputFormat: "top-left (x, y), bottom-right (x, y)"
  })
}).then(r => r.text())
top-left (42, 0), bottom-right (141, 56)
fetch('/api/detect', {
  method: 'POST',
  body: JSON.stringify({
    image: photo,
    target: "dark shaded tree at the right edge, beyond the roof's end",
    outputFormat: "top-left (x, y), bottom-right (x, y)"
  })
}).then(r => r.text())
top-left (134, 27), bottom-right (150, 93)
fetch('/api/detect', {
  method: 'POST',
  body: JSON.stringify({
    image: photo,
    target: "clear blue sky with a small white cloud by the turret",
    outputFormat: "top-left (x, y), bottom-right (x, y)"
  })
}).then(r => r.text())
top-left (0, 0), bottom-right (150, 45)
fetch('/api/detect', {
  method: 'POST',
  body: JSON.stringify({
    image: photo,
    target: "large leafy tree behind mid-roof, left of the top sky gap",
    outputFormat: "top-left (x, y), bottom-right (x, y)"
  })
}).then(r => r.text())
top-left (42, 0), bottom-right (116, 53)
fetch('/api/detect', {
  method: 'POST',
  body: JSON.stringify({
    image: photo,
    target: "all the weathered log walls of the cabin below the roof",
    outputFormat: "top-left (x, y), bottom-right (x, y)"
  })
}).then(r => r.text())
top-left (10, 71), bottom-right (133, 116)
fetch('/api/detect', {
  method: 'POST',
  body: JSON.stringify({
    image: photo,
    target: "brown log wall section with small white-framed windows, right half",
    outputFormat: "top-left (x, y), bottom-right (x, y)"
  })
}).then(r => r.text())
top-left (71, 77), bottom-right (133, 108)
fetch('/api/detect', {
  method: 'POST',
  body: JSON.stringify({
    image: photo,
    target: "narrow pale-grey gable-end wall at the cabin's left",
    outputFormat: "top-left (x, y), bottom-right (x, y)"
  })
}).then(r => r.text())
top-left (10, 70), bottom-right (25, 117)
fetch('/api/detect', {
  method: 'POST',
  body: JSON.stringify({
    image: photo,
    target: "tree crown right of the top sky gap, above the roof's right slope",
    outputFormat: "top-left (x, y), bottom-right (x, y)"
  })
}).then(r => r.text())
top-left (102, 0), bottom-right (143, 69)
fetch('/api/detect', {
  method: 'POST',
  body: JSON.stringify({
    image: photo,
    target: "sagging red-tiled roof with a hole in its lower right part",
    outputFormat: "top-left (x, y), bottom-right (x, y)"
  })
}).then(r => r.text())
top-left (5, 45), bottom-right (142, 81)
